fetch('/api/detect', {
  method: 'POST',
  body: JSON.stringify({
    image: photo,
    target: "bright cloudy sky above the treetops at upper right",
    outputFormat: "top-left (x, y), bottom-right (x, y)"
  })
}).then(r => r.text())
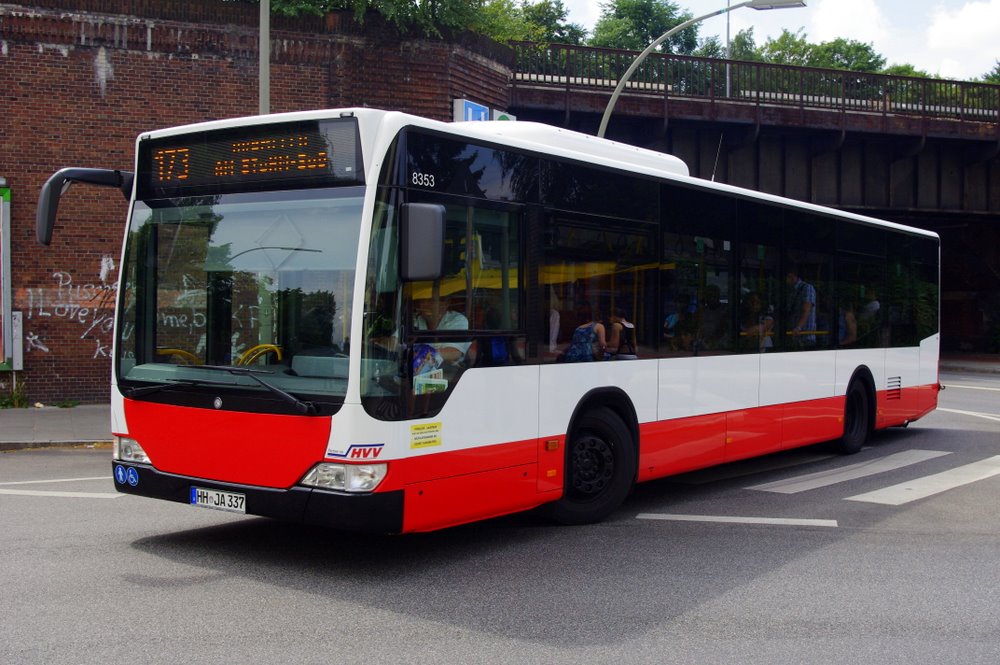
top-left (563, 0), bottom-right (1000, 80)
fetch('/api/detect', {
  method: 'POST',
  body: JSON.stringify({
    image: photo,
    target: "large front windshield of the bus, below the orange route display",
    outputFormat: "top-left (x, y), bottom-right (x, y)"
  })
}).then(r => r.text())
top-left (117, 187), bottom-right (364, 408)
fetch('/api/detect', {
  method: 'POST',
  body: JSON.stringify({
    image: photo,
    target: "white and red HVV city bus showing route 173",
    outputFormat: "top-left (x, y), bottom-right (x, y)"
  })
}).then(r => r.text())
top-left (38, 109), bottom-right (939, 533)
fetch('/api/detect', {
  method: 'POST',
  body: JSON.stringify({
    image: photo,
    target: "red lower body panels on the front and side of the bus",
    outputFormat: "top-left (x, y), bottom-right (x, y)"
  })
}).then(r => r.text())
top-left (125, 385), bottom-right (938, 531)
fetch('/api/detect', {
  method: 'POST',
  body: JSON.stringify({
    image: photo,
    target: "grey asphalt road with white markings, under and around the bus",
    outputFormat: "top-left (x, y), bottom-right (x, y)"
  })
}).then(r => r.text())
top-left (0, 374), bottom-right (1000, 665)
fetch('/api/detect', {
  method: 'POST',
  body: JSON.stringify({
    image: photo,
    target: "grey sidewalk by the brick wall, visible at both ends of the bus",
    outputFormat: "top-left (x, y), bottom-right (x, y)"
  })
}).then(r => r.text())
top-left (0, 355), bottom-right (1000, 451)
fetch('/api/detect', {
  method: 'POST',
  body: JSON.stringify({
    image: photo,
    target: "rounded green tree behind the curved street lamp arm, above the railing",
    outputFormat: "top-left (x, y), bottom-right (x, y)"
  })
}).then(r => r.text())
top-left (589, 0), bottom-right (698, 55)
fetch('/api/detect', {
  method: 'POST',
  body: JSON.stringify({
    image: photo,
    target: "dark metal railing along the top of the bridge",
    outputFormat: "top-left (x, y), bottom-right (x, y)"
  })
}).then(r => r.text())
top-left (511, 42), bottom-right (1000, 124)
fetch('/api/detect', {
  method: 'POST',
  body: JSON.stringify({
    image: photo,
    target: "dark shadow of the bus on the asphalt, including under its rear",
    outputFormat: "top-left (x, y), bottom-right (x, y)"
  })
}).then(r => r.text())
top-left (129, 428), bottom-right (976, 647)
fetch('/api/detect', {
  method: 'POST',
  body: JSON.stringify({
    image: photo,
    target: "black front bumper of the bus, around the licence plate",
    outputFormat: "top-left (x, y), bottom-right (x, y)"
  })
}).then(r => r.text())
top-left (111, 460), bottom-right (403, 533)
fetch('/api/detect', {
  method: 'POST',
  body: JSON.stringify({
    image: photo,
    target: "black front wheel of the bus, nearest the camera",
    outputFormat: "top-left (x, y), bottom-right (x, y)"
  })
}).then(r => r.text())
top-left (546, 407), bottom-right (636, 524)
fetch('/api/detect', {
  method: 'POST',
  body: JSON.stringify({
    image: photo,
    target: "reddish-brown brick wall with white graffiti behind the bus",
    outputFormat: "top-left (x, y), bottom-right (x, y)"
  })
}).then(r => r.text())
top-left (0, 0), bottom-right (510, 402)
